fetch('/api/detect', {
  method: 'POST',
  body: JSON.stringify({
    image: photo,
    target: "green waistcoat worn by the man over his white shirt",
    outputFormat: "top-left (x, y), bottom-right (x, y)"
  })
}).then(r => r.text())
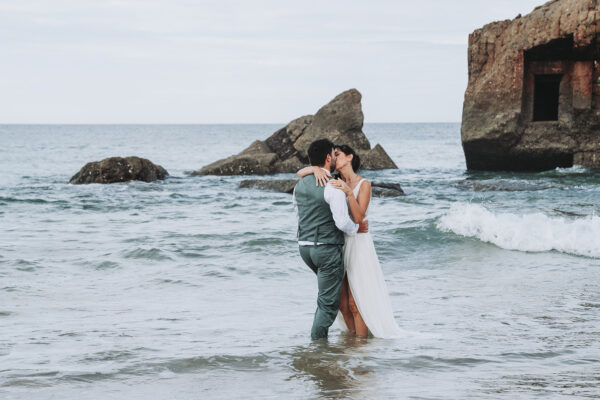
top-left (294, 174), bottom-right (344, 245)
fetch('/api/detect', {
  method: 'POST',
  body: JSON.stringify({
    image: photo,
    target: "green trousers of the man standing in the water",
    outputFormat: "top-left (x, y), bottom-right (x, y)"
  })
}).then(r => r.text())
top-left (300, 245), bottom-right (344, 340)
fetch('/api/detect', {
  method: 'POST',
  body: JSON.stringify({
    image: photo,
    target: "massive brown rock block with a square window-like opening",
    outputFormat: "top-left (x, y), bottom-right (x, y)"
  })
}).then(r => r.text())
top-left (461, 0), bottom-right (600, 171)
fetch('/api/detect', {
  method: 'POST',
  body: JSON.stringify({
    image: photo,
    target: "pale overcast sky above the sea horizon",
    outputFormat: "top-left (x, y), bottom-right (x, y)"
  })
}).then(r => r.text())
top-left (0, 0), bottom-right (543, 123)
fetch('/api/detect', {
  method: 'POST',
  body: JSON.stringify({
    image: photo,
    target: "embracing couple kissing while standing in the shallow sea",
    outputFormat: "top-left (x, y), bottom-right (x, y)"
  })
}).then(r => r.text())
top-left (293, 139), bottom-right (401, 340)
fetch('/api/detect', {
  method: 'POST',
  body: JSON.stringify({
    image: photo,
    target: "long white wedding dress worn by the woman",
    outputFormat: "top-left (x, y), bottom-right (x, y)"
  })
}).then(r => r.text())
top-left (337, 179), bottom-right (403, 339)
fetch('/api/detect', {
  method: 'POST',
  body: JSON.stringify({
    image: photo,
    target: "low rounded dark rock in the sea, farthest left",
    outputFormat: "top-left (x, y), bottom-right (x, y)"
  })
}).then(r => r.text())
top-left (69, 157), bottom-right (169, 184)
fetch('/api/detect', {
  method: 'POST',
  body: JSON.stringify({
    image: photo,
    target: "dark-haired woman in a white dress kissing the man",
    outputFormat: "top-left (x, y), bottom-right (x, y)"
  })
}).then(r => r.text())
top-left (298, 145), bottom-right (402, 338)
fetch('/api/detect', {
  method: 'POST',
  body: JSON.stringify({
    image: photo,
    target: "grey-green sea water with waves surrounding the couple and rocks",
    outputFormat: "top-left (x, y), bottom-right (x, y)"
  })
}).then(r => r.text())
top-left (0, 124), bottom-right (600, 399)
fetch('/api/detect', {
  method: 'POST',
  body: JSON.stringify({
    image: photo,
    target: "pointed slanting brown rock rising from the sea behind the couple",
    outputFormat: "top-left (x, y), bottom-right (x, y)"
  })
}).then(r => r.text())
top-left (191, 89), bottom-right (397, 175)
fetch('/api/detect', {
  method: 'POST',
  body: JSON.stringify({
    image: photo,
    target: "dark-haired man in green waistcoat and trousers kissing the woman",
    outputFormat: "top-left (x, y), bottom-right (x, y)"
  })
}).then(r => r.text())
top-left (293, 139), bottom-right (366, 340)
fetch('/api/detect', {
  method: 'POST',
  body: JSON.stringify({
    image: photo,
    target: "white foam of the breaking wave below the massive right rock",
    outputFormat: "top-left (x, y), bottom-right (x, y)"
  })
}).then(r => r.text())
top-left (437, 203), bottom-right (600, 258)
